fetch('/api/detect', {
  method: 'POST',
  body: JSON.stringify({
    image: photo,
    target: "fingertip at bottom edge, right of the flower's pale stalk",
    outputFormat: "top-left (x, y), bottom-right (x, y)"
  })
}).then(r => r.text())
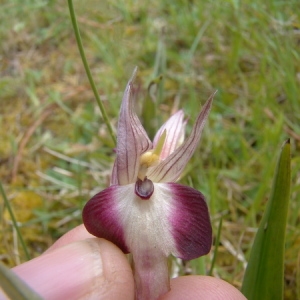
top-left (161, 275), bottom-right (246, 300)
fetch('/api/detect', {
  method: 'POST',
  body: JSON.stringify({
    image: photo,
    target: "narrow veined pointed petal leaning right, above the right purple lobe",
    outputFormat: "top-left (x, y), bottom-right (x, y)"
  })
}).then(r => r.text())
top-left (147, 92), bottom-right (216, 182)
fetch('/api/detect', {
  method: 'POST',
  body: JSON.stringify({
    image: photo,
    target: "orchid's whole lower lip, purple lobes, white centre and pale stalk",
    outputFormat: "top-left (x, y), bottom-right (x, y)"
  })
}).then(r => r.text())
top-left (83, 183), bottom-right (212, 299)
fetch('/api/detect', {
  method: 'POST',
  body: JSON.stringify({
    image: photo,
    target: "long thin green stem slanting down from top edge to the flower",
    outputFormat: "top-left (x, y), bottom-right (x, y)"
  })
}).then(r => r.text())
top-left (68, 0), bottom-right (116, 144)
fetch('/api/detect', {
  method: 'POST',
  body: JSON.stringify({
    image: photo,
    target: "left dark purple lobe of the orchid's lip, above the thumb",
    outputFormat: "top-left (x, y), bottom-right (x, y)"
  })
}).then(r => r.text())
top-left (82, 185), bottom-right (129, 253)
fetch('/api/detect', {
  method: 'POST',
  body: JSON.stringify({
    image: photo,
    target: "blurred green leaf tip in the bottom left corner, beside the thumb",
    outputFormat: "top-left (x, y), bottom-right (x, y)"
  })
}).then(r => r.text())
top-left (0, 262), bottom-right (43, 300)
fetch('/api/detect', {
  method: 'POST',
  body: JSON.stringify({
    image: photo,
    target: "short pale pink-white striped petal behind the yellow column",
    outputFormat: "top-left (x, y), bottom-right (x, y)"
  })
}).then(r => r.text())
top-left (153, 110), bottom-right (186, 160)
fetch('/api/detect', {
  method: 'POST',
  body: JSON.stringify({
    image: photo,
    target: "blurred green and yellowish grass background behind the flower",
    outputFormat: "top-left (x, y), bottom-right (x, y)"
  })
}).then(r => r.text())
top-left (0, 0), bottom-right (300, 299)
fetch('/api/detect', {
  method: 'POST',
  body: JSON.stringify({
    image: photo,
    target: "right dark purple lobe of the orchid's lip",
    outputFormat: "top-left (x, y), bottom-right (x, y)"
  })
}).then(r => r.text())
top-left (167, 183), bottom-right (212, 260)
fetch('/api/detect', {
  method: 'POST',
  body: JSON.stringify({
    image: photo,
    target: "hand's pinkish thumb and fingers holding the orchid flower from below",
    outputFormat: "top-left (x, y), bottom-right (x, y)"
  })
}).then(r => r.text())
top-left (0, 225), bottom-right (246, 300)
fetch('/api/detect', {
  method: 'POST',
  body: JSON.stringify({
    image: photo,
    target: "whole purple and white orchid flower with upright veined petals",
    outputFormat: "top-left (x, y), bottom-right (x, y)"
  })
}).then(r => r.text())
top-left (83, 70), bottom-right (214, 300)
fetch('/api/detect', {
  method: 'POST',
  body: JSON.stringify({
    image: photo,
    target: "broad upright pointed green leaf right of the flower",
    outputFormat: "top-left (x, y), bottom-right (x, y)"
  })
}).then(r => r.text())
top-left (242, 140), bottom-right (291, 300)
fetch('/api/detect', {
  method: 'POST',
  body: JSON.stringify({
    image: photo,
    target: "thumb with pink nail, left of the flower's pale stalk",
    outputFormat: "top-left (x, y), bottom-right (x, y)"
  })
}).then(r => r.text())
top-left (10, 238), bottom-right (134, 300)
